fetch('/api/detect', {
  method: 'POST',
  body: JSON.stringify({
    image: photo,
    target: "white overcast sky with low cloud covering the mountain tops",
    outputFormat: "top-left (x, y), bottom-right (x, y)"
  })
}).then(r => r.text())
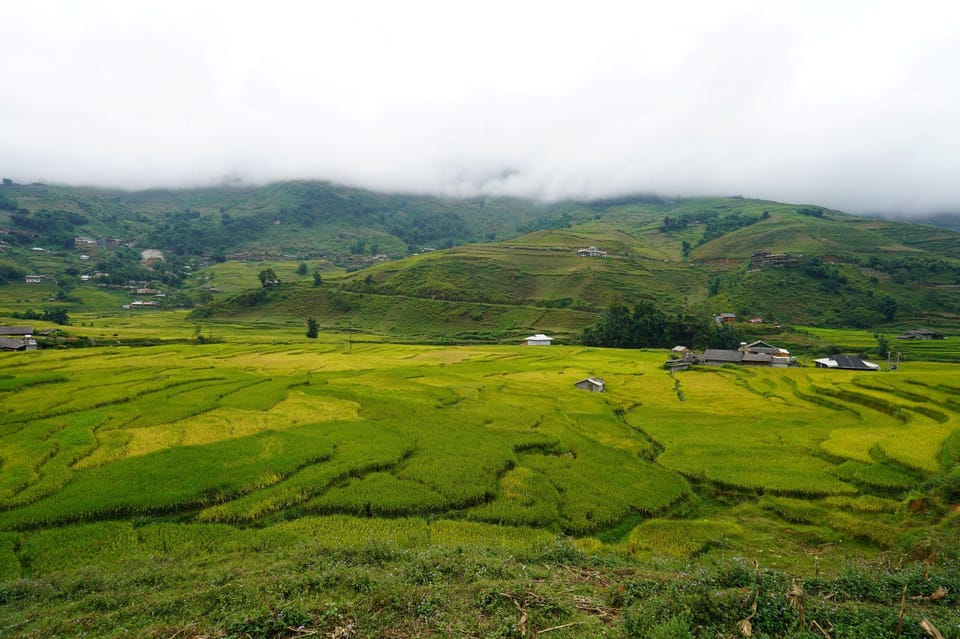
top-left (0, 0), bottom-right (960, 214)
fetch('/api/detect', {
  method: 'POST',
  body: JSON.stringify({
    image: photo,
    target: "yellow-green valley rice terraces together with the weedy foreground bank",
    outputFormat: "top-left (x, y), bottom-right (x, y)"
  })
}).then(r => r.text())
top-left (0, 338), bottom-right (960, 637)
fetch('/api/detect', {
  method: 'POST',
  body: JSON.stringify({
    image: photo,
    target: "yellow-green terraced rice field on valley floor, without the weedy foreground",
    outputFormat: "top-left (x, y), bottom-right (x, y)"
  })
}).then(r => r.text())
top-left (0, 340), bottom-right (960, 574)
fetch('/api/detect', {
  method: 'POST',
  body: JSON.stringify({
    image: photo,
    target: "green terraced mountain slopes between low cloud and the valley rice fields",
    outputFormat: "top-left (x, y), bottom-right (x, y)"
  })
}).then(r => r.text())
top-left (0, 181), bottom-right (960, 341)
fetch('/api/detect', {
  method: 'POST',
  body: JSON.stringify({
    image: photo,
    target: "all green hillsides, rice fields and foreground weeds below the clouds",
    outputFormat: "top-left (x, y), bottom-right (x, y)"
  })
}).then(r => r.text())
top-left (0, 182), bottom-right (960, 639)
